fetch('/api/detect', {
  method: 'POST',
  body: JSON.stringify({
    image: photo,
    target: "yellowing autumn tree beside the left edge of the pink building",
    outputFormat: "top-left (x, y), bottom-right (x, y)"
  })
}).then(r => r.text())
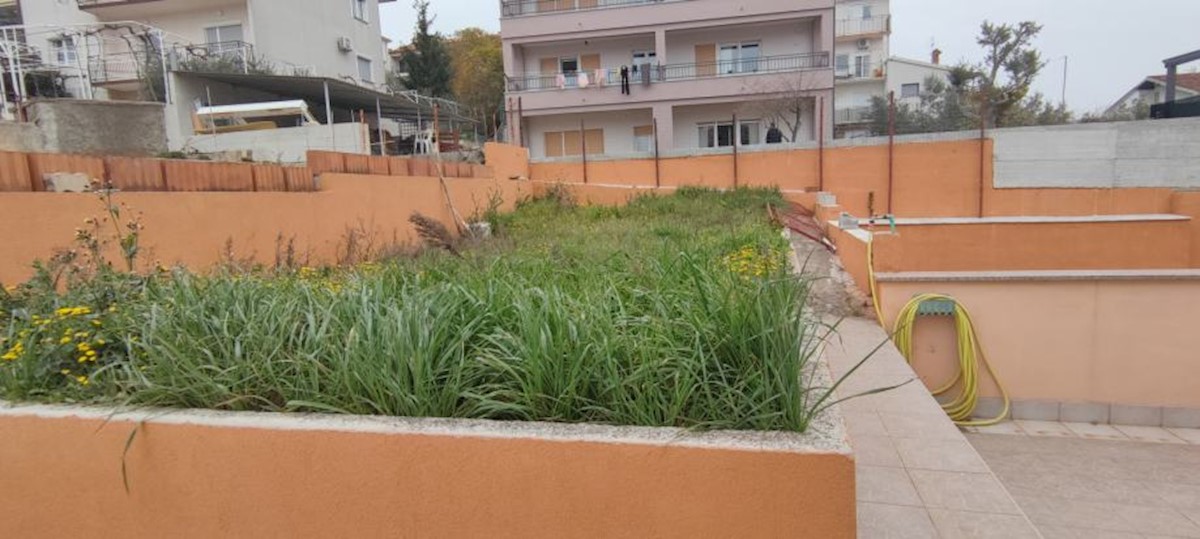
top-left (449, 28), bottom-right (504, 134)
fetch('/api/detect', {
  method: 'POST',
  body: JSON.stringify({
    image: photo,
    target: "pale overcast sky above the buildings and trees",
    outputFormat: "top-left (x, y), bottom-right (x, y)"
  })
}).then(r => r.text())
top-left (383, 0), bottom-right (1200, 112)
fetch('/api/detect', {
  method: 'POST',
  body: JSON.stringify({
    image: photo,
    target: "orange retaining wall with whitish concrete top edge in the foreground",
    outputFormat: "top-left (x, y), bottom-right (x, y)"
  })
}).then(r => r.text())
top-left (0, 407), bottom-right (856, 538)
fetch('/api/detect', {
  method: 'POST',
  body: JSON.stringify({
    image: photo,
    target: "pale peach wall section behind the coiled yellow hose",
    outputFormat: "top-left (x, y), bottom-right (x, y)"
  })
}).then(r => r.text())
top-left (880, 280), bottom-right (1200, 408)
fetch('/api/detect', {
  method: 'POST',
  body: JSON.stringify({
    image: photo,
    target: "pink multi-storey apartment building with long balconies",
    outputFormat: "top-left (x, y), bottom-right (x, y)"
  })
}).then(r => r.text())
top-left (500, 0), bottom-right (835, 158)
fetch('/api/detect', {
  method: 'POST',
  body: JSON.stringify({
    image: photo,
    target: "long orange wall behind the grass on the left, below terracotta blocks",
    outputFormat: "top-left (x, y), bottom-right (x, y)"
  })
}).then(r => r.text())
top-left (0, 174), bottom-right (529, 283)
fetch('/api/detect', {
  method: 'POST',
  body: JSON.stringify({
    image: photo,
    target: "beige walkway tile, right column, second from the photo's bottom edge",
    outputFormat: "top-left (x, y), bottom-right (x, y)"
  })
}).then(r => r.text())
top-left (908, 469), bottom-right (1021, 515)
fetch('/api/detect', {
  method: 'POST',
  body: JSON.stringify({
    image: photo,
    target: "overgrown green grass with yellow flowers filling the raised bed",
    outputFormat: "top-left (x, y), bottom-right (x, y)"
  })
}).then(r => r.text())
top-left (0, 190), bottom-right (844, 431)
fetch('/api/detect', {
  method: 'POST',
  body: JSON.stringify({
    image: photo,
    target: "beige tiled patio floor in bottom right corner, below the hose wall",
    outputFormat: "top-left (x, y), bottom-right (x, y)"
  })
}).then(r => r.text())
top-left (967, 421), bottom-right (1200, 539)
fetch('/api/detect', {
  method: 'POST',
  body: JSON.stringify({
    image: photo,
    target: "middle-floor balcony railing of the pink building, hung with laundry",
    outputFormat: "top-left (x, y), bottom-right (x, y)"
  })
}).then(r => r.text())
top-left (508, 53), bottom-right (829, 91)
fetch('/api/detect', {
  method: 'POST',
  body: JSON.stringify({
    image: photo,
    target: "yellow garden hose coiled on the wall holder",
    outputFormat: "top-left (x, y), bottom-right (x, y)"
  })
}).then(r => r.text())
top-left (866, 234), bottom-right (1012, 426)
